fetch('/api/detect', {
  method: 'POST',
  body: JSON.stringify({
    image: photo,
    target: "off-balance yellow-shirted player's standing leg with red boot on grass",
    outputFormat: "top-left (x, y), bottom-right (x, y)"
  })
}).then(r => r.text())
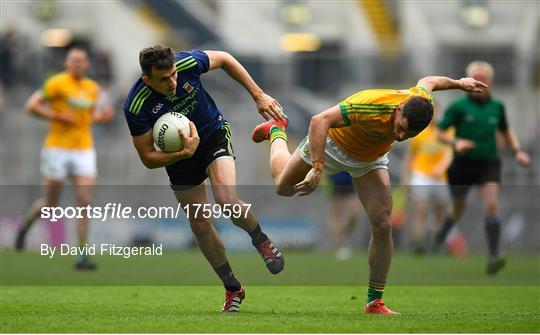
top-left (353, 169), bottom-right (399, 314)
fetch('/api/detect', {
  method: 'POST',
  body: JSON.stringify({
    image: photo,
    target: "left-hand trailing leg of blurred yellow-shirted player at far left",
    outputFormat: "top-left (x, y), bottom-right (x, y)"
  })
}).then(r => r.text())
top-left (15, 178), bottom-right (64, 250)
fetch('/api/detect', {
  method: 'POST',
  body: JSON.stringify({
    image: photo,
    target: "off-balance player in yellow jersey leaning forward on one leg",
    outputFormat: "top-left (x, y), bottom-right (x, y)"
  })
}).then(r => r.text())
top-left (252, 77), bottom-right (483, 314)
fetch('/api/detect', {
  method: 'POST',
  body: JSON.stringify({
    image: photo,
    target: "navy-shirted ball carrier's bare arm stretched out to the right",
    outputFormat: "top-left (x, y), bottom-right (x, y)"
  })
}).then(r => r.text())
top-left (205, 51), bottom-right (284, 121)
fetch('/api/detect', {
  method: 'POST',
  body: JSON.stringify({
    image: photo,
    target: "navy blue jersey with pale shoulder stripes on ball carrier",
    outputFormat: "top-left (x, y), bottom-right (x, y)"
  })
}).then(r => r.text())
top-left (124, 50), bottom-right (223, 144)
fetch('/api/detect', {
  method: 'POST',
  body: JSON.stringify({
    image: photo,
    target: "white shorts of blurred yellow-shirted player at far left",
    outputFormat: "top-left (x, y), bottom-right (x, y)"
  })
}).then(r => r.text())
top-left (41, 148), bottom-right (97, 181)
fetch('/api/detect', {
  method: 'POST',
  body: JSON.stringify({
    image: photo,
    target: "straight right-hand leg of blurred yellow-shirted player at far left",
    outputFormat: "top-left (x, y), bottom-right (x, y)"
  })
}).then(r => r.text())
top-left (71, 175), bottom-right (96, 270)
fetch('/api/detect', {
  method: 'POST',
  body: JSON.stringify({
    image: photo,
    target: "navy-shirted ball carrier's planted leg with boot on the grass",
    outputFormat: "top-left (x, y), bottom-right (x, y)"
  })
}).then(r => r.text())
top-left (174, 183), bottom-right (245, 312)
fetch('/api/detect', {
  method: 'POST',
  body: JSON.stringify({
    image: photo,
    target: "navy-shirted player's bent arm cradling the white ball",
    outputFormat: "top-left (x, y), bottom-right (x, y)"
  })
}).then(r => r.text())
top-left (131, 121), bottom-right (200, 169)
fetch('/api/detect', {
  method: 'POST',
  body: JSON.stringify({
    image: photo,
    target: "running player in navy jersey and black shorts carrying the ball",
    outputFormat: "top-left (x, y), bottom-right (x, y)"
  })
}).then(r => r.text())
top-left (124, 46), bottom-right (285, 312)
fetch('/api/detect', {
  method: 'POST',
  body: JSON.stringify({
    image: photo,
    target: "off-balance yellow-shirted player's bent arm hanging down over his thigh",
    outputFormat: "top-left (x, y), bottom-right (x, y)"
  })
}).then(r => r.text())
top-left (294, 105), bottom-right (345, 196)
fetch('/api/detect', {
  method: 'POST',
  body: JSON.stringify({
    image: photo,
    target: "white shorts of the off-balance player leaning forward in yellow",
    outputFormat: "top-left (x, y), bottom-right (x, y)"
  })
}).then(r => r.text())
top-left (298, 136), bottom-right (389, 178)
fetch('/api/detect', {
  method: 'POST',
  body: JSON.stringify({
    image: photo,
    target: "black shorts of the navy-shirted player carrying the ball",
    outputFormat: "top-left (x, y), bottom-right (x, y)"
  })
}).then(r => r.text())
top-left (165, 122), bottom-right (236, 191)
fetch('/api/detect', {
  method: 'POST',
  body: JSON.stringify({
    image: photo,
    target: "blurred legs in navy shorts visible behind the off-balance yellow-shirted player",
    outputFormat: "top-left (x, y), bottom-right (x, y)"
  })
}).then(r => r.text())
top-left (328, 171), bottom-right (360, 260)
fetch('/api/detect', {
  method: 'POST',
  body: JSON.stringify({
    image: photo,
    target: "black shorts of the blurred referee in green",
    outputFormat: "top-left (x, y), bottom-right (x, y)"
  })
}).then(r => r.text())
top-left (448, 158), bottom-right (501, 198)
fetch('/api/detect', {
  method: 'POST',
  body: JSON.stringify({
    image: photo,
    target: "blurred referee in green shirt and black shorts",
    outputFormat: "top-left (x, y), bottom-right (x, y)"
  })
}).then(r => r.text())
top-left (435, 61), bottom-right (529, 274)
